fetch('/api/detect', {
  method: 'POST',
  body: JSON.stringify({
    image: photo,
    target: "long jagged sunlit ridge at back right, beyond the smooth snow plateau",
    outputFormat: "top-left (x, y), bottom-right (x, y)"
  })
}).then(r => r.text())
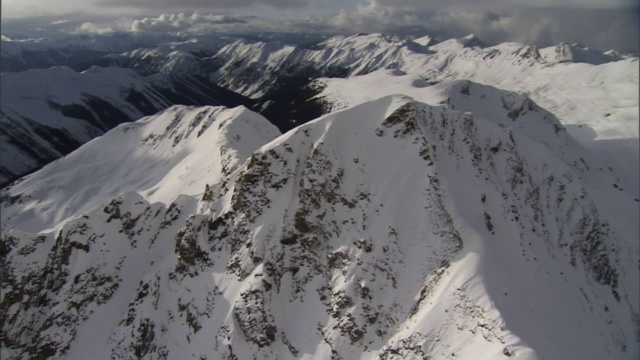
top-left (214, 34), bottom-right (640, 160)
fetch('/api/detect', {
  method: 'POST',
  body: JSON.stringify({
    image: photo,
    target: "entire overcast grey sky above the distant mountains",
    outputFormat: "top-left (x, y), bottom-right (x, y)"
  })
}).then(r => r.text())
top-left (2, 0), bottom-right (640, 54)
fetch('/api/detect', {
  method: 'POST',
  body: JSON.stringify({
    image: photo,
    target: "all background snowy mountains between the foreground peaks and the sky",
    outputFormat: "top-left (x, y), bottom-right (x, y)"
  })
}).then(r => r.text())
top-left (0, 34), bottom-right (638, 188)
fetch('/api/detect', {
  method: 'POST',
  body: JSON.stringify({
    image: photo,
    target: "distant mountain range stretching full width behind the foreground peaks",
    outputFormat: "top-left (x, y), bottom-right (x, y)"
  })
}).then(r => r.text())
top-left (0, 34), bottom-right (637, 188)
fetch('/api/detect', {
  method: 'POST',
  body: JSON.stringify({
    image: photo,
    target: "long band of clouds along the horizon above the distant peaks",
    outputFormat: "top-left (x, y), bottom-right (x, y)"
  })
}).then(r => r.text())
top-left (3, 0), bottom-right (640, 54)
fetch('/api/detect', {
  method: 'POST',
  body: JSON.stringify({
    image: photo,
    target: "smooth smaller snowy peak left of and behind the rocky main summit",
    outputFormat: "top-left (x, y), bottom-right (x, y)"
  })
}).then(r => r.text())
top-left (2, 106), bottom-right (280, 232)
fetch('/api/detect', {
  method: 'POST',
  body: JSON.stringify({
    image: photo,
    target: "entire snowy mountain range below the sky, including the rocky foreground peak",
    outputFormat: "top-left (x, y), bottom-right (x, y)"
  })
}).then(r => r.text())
top-left (0, 34), bottom-right (640, 359)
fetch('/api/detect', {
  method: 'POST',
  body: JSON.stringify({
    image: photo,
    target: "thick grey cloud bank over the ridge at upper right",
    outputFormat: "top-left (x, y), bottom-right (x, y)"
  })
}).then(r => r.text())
top-left (325, 0), bottom-right (640, 54)
